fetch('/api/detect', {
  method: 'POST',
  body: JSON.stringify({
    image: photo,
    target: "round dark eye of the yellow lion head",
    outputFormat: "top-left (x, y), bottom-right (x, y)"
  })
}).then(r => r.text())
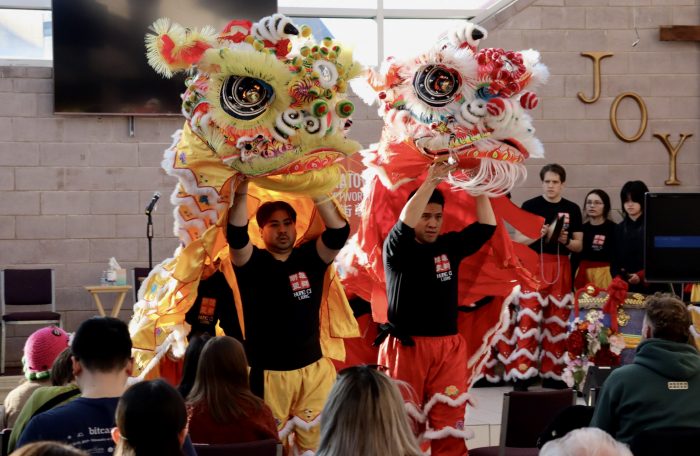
top-left (221, 76), bottom-right (275, 120)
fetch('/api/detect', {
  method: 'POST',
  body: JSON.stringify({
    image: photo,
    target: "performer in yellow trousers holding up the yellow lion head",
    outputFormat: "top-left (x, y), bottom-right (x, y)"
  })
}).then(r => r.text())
top-left (227, 181), bottom-right (350, 453)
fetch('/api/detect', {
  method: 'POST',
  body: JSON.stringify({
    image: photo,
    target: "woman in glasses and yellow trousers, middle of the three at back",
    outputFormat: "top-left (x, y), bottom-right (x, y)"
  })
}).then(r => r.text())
top-left (572, 188), bottom-right (615, 290)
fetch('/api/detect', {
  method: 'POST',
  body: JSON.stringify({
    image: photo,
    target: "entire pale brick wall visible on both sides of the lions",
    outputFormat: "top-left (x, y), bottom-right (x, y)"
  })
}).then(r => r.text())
top-left (0, 0), bottom-right (700, 364)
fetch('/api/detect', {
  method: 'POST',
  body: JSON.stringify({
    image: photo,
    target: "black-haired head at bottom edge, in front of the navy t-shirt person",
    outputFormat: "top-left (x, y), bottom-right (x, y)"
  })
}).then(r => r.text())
top-left (112, 380), bottom-right (187, 456)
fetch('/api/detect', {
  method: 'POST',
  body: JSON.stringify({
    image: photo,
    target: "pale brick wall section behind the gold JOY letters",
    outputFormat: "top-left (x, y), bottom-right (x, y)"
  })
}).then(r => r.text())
top-left (482, 0), bottom-right (700, 209)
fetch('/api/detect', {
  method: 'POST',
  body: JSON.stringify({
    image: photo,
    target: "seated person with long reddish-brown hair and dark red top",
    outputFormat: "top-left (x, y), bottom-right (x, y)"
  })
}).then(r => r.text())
top-left (187, 336), bottom-right (278, 444)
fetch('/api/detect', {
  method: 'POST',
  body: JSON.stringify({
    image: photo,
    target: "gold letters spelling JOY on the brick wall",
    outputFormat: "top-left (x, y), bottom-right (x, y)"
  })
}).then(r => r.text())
top-left (577, 52), bottom-right (693, 185)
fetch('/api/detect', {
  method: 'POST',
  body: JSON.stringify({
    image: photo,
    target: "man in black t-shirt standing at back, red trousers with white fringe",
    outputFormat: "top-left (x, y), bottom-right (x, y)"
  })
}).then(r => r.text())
top-left (505, 163), bottom-right (583, 389)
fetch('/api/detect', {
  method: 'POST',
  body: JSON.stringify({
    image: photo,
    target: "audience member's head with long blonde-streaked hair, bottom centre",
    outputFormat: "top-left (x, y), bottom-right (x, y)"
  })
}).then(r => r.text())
top-left (316, 366), bottom-right (422, 456)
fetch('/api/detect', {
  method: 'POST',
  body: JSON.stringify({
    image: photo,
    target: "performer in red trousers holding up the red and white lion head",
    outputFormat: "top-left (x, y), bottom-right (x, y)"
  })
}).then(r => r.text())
top-left (379, 163), bottom-right (496, 455)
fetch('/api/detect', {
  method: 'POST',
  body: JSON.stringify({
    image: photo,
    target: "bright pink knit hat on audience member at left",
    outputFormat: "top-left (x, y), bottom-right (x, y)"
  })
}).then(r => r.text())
top-left (22, 326), bottom-right (68, 380)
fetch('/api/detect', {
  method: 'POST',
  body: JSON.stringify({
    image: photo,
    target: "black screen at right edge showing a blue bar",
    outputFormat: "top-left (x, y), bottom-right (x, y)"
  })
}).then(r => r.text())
top-left (644, 193), bottom-right (700, 282)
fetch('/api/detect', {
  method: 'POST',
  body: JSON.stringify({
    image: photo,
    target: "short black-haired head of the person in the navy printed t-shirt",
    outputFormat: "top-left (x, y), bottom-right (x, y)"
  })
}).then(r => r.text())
top-left (71, 317), bottom-right (131, 373)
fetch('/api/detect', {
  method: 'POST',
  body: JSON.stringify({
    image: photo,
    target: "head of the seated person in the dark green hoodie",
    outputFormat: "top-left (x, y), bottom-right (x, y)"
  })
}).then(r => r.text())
top-left (642, 293), bottom-right (691, 343)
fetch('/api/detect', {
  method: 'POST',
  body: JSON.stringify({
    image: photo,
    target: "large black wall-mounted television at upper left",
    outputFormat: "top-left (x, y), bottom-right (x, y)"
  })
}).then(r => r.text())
top-left (52, 0), bottom-right (277, 116)
